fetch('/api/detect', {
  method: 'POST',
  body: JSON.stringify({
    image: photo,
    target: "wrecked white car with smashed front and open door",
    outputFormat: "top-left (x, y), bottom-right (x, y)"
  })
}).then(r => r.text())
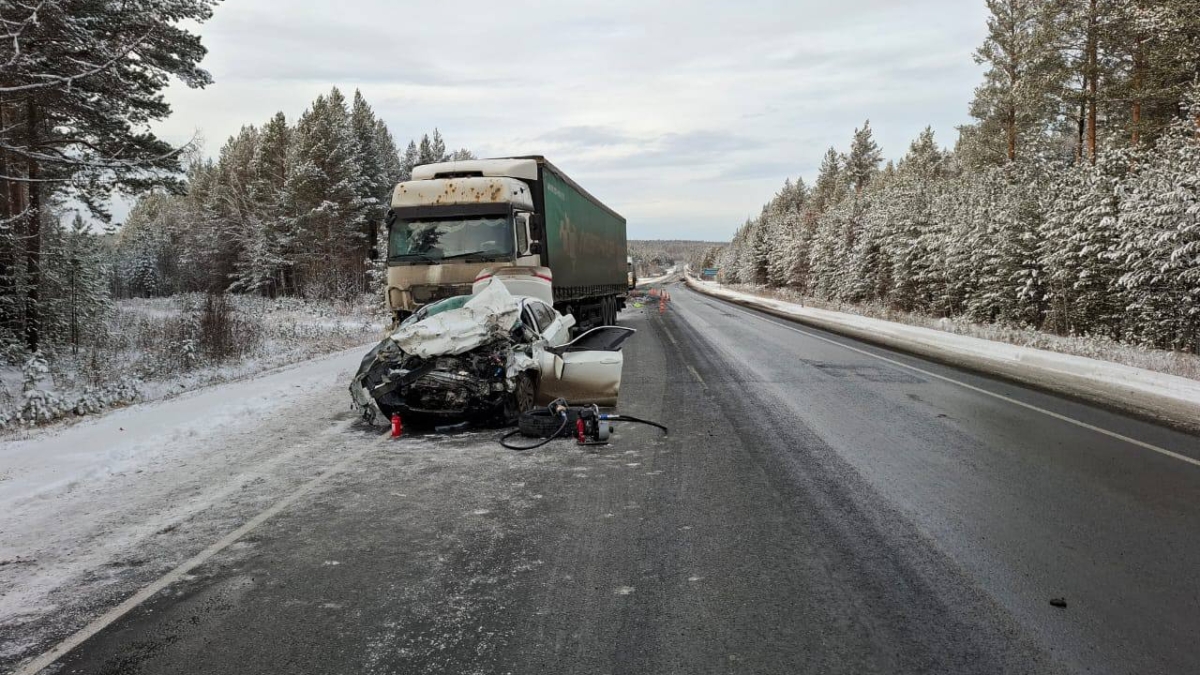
top-left (350, 270), bottom-right (636, 425)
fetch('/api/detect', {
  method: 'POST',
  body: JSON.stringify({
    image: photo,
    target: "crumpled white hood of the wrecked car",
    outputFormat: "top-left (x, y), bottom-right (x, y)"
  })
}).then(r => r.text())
top-left (391, 279), bottom-right (521, 359)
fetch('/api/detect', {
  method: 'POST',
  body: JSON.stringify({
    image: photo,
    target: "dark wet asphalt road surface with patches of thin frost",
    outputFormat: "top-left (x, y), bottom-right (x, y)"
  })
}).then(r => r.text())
top-left (9, 279), bottom-right (1200, 674)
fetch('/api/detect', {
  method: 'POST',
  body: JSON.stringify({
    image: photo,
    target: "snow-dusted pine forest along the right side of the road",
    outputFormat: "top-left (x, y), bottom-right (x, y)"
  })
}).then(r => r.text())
top-left (701, 0), bottom-right (1200, 352)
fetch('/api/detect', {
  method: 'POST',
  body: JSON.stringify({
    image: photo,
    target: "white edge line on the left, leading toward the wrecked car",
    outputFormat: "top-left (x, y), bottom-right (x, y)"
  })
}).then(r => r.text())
top-left (13, 430), bottom-right (391, 675)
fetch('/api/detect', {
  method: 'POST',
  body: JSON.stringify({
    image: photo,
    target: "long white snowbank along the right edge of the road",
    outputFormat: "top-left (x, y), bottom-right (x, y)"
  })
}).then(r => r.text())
top-left (686, 276), bottom-right (1200, 431)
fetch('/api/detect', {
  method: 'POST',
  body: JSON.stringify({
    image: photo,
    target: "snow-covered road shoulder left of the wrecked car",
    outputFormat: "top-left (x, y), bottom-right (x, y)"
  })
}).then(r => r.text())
top-left (0, 345), bottom-right (373, 657)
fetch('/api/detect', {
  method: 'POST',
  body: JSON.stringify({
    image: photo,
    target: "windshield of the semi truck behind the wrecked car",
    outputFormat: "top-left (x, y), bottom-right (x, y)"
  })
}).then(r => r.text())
top-left (388, 216), bottom-right (512, 262)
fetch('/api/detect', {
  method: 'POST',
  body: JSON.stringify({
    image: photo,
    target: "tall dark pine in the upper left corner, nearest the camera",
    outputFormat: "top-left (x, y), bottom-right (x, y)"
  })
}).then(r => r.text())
top-left (0, 0), bottom-right (216, 351)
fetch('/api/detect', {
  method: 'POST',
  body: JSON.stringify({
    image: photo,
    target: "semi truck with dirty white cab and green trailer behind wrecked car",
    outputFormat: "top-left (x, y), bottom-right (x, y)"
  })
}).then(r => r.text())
top-left (385, 155), bottom-right (629, 330)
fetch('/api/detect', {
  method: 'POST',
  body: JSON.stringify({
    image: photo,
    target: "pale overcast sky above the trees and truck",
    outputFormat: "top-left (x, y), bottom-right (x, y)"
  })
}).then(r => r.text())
top-left (147, 0), bottom-right (985, 240)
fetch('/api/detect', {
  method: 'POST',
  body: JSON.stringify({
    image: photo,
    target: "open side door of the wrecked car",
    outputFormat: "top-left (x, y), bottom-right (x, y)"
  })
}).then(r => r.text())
top-left (538, 325), bottom-right (637, 406)
